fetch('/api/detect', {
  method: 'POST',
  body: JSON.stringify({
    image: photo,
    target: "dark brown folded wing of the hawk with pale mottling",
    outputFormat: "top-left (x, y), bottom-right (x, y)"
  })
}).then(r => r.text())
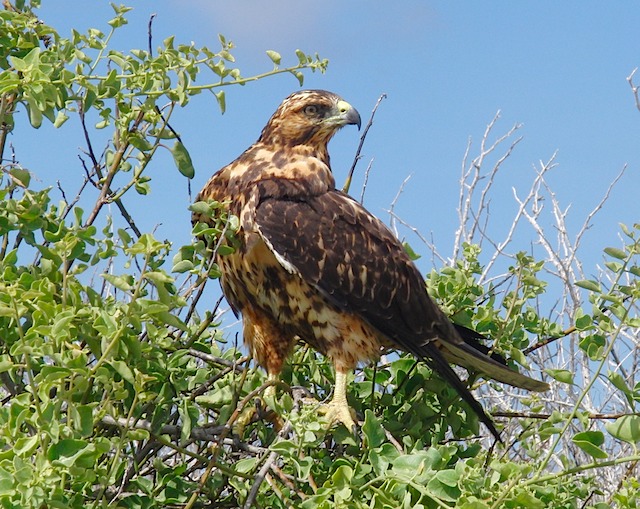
top-left (256, 191), bottom-right (448, 356)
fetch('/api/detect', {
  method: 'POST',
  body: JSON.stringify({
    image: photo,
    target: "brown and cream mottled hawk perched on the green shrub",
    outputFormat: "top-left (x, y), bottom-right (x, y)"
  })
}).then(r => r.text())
top-left (193, 90), bottom-right (548, 438)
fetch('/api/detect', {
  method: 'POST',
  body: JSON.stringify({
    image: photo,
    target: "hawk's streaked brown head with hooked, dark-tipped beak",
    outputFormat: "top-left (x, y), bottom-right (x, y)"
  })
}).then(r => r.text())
top-left (258, 90), bottom-right (360, 148)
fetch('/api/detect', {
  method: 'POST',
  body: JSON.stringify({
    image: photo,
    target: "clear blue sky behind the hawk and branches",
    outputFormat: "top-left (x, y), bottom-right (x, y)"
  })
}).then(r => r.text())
top-left (11, 0), bottom-right (640, 292)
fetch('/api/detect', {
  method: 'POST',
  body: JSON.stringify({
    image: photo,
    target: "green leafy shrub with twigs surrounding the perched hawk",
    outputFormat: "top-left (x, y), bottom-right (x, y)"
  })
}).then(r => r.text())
top-left (0, 1), bottom-right (640, 509)
